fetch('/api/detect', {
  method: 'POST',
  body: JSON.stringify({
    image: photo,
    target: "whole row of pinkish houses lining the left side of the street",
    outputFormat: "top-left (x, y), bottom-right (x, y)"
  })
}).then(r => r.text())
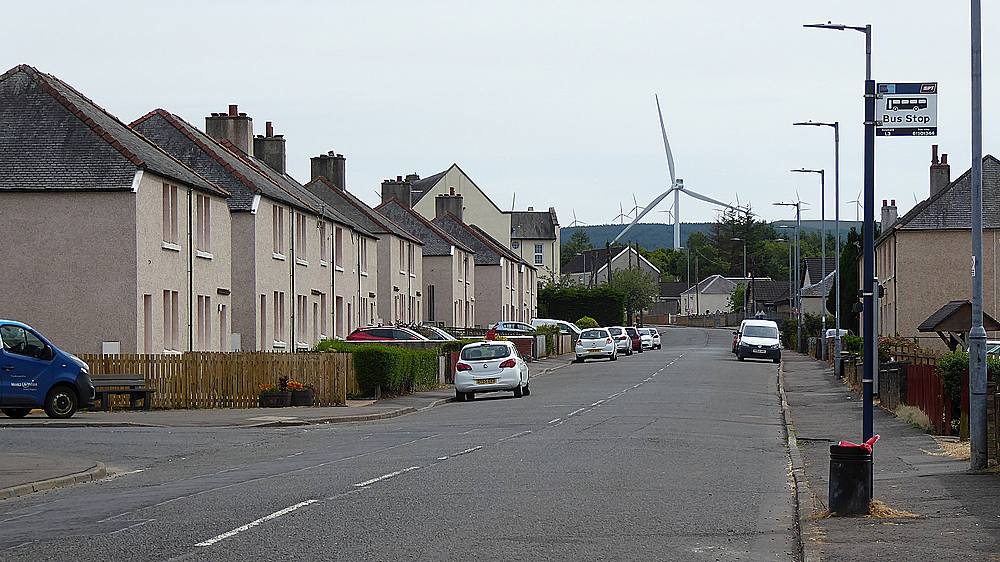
top-left (0, 65), bottom-right (559, 353)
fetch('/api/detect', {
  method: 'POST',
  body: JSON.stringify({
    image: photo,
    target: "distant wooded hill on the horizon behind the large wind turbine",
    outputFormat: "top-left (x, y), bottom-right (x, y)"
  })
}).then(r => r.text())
top-left (560, 220), bottom-right (861, 250)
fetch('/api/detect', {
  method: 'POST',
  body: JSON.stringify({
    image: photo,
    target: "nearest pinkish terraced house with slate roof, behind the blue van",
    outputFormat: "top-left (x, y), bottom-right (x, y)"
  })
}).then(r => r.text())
top-left (0, 65), bottom-right (233, 353)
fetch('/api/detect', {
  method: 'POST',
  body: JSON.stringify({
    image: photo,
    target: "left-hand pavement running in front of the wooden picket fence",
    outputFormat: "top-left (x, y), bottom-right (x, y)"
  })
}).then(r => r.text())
top-left (0, 355), bottom-right (569, 428)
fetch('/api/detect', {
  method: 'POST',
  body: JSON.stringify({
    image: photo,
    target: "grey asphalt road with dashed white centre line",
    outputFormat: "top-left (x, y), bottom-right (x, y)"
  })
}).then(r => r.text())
top-left (0, 328), bottom-right (798, 561)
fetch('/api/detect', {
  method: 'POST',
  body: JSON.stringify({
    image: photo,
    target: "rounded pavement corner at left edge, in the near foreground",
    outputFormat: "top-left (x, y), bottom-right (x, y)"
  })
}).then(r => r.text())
top-left (0, 453), bottom-right (108, 500)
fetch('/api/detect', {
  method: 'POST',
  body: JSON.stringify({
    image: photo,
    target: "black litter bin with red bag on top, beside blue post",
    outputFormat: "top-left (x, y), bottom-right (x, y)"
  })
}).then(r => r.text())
top-left (829, 445), bottom-right (872, 515)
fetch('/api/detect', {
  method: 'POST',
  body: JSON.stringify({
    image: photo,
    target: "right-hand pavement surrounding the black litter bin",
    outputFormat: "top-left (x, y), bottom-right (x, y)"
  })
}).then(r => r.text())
top-left (782, 352), bottom-right (1000, 561)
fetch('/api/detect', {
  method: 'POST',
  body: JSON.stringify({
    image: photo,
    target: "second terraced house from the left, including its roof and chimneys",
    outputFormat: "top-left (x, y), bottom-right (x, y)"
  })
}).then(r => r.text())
top-left (132, 105), bottom-right (374, 351)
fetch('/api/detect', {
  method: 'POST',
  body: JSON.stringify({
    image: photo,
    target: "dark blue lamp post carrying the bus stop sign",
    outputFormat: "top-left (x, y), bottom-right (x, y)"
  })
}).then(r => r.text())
top-left (804, 20), bottom-right (876, 440)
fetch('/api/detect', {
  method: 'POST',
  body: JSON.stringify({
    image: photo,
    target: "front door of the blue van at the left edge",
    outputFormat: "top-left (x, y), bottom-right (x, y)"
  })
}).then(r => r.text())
top-left (0, 324), bottom-right (53, 406)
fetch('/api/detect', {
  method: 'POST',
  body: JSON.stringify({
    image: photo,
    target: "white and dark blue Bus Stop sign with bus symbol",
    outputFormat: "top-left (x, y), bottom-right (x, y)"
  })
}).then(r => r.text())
top-left (875, 82), bottom-right (937, 137)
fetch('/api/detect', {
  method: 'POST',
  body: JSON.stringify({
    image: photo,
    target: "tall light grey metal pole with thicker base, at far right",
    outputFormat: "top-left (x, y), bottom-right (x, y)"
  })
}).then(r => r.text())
top-left (968, 0), bottom-right (987, 470)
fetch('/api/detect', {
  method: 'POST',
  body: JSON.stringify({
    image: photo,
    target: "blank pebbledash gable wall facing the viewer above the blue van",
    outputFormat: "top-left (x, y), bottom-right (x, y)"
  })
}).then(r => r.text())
top-left (0, 191), bottom-right (137, 353)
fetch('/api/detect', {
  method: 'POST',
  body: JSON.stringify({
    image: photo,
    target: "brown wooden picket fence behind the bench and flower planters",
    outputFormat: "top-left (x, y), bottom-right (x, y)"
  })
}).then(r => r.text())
top-left (80, 352), bottom-right (357, 409)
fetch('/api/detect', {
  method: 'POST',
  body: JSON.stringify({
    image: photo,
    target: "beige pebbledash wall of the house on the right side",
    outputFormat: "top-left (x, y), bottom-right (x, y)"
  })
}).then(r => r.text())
top-left (875, 229), bottom-right (1000, 351)
